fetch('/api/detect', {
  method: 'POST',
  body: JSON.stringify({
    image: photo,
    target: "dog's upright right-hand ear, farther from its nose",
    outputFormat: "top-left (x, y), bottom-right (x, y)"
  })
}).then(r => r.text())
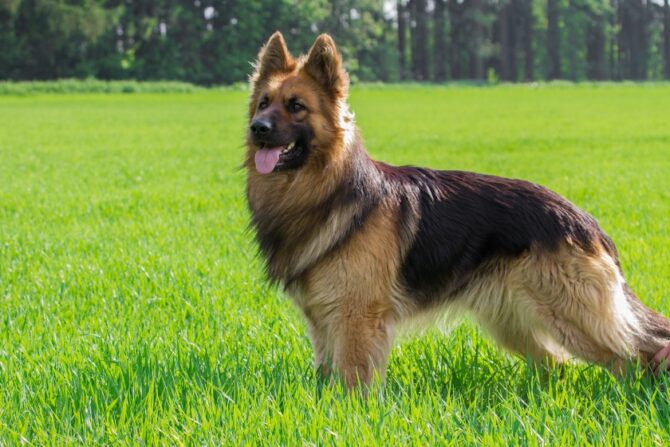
top-left (304, 34), bottom-right (349, 97)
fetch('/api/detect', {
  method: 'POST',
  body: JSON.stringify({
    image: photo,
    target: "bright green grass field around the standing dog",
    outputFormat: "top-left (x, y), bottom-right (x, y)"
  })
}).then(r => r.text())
top-left (0, 85), bottom-right (670, 446)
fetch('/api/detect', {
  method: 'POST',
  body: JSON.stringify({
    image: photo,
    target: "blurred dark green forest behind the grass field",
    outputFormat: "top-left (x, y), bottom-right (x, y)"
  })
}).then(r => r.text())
top-left (0, 0), bottom-right (670, 85)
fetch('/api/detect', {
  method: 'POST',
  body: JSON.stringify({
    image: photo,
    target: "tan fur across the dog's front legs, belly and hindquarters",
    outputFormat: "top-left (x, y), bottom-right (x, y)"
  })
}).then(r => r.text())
top-left (293, 209), bottom-right (663, 385)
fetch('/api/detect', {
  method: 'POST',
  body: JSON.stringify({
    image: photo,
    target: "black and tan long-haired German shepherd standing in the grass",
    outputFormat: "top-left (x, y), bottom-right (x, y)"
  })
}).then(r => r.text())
top-left (245, 32), bottom-right (670, 388)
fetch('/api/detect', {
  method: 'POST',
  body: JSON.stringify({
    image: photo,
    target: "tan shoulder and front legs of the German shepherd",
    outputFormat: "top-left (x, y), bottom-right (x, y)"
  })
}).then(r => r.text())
top-left (298, 204), bottom-right (400, 386)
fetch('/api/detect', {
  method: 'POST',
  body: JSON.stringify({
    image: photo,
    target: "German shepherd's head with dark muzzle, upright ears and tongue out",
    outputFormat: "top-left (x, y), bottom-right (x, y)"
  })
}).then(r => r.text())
top-left (247, 32), bottom-right (351, 174)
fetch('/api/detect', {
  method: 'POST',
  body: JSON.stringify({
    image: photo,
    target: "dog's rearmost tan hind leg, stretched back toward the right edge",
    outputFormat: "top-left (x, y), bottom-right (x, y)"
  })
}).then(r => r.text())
top-left (523, 246), bottom-right (670, 373)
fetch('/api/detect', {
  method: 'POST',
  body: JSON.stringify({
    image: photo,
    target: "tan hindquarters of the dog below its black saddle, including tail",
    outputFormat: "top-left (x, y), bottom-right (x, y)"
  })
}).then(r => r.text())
top-left (468, 243), bottom-right (670, 372)
